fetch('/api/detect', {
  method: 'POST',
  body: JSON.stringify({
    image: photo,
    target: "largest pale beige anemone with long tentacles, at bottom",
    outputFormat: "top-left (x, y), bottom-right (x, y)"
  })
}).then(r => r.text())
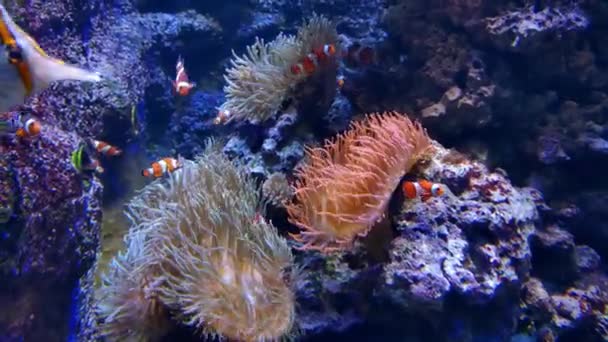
top-left (98, 142), bottom-right (295, 341)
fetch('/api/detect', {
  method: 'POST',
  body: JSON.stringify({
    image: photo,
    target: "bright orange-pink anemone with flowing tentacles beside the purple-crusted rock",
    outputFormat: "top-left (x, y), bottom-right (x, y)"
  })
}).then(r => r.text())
top-left (287, 112), bottom-right (431, 252)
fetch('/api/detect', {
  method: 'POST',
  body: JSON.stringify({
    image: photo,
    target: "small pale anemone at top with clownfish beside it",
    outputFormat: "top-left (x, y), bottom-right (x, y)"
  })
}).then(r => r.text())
top-left (219, 15), bottom-right (338, 124)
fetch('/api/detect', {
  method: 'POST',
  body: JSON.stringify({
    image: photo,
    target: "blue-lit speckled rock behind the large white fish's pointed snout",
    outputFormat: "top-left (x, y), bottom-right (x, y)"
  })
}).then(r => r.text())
top-left (11, 0), bottom-right (220, 144)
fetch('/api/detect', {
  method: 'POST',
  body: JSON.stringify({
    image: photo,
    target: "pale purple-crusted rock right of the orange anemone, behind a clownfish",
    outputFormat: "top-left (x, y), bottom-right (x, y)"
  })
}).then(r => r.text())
top-left (383, 144), bottom-right (538, 306)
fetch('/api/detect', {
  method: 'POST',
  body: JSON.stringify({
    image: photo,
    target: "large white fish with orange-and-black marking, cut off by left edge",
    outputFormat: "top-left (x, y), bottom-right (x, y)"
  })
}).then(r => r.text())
top-left (0, 4), bottom-right (102, 112)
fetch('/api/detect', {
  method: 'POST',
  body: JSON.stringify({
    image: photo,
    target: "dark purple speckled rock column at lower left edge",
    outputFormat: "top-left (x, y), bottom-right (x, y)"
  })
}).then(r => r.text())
top-left (0, 125), bottom-right (102, 341)
